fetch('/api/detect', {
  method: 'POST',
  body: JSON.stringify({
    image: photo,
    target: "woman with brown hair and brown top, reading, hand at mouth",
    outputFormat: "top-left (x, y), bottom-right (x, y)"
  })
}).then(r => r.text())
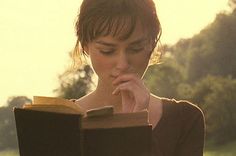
top-left (73, 0), bottom-right (204, 156)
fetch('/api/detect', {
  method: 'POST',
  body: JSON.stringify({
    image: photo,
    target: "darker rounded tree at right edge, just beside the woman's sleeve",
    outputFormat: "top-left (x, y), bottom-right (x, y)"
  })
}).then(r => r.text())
top-left (191, 75), bottom-right (236, 144)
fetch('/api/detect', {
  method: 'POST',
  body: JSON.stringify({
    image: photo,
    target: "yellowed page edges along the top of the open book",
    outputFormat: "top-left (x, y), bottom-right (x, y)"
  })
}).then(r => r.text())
top-left (23, 96), bottom-right (150, 129)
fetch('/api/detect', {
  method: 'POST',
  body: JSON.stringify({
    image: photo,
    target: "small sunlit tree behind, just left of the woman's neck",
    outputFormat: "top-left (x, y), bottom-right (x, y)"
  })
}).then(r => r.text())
top-left (54, 65), bottom-right (93, 99)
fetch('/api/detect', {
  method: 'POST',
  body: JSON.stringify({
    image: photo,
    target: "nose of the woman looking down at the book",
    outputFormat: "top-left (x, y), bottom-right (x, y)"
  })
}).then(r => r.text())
top-left (116, 53), bottom-right (130, 72)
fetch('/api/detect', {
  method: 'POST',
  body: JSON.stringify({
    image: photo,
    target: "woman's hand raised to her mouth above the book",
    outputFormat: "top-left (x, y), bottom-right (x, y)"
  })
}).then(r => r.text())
top-left (112, 73), bottom-right (150, 112)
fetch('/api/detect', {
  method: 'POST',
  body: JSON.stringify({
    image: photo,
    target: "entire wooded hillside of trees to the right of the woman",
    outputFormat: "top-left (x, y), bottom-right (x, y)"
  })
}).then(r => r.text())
top-left (145, 8), bottom-right (236, 144)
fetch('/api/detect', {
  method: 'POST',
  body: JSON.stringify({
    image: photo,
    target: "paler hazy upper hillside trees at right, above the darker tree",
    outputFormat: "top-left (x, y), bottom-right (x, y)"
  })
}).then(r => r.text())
top-left (170, 10), bottom-right (236, 83)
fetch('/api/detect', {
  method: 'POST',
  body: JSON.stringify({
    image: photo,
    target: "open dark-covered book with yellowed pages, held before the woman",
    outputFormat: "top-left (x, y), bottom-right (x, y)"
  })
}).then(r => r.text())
top-left (14, 96), bottom-right (152, 156)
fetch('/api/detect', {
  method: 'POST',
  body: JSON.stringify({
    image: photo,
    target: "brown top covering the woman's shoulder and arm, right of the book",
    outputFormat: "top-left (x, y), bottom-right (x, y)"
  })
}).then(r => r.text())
top-left (154, 98), bottom-right (205, 155)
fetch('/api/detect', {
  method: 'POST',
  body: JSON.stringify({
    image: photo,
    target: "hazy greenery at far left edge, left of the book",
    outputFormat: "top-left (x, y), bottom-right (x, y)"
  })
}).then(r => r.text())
top-left (0, 96), bottom-right (31, 150)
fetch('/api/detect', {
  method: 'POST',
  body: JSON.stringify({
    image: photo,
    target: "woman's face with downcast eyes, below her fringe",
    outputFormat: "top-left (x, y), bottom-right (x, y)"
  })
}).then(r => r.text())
top-left (84, 24), bottom-right (152, 83)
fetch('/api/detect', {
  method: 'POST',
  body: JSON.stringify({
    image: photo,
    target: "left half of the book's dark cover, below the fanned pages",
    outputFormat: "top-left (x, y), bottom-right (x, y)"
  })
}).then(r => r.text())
top-left (14, 108), bottom-right (83, 156)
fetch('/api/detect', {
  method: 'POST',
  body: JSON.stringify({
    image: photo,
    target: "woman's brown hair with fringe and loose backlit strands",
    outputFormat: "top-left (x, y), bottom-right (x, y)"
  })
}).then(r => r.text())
top-left (73, 0), bottom-right (161, 66)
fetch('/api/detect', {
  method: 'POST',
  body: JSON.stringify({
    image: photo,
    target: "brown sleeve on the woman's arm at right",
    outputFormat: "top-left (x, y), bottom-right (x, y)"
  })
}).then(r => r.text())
top-left (176, 101), bottom-right (205, 156)
